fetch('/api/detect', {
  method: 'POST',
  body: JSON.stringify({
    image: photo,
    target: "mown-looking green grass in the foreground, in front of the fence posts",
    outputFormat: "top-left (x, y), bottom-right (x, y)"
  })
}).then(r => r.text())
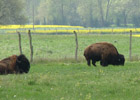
top-left (0, 62), bottom-right (140, 100)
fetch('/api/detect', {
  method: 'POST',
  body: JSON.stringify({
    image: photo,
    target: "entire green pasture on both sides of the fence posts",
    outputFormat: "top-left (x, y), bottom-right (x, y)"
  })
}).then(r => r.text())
top-left (0, 34), bottom-right (140, 100)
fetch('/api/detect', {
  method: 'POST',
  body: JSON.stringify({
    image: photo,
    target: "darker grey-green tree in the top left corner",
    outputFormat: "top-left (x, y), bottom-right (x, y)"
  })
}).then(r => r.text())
top-left (0, 0), bottom-right (27, 25)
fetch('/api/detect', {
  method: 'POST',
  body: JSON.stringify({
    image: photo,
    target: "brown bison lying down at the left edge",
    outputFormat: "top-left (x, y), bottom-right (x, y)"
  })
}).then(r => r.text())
top-left (0, 54), bottom-right (30, 74)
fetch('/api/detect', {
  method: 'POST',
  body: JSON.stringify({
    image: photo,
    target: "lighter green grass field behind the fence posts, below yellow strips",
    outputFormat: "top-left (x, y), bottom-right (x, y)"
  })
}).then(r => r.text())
top-left (0, 34), bottom-right (140, 60)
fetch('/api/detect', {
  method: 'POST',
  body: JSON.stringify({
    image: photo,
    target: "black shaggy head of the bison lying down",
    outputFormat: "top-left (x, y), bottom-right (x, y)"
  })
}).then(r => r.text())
top-left (16, 54), bottom-right (30, 73)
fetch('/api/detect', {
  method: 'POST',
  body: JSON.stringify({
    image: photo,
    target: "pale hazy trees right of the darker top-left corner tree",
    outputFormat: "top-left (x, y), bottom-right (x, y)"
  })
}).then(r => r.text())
top-left (23, 0), bottom-right (140, 27)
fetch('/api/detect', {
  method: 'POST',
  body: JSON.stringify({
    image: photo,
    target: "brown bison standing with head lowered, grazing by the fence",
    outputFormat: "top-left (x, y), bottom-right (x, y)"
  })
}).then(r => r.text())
top-left (84, 42), bottom-right (125, 66)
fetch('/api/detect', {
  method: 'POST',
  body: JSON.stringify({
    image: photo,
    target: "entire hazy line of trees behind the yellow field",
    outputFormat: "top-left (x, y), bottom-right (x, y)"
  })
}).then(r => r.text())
top-left (0, 0), bottom-right (140, 27)
